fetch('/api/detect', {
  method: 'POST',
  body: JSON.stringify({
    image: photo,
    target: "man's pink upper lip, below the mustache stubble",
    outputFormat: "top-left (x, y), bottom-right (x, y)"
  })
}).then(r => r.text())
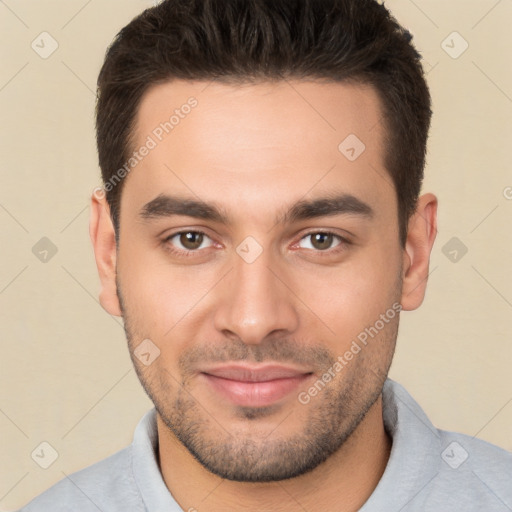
top-left (201, 364), bottom-right (312, 382)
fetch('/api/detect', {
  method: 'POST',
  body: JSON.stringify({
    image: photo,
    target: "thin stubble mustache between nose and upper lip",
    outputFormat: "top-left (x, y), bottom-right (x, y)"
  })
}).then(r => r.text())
top-left (178, 338), bottom-right (336, 375)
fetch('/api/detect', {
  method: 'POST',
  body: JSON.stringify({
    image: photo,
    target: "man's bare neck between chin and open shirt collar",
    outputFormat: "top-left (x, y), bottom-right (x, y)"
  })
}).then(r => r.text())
top-left (157, 396), bottom-right (391, 512)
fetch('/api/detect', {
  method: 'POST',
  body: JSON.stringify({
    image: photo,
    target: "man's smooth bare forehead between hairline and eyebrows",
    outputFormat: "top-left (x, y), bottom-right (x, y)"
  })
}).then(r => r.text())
top-left (123, 80), bottom-right (394, 223)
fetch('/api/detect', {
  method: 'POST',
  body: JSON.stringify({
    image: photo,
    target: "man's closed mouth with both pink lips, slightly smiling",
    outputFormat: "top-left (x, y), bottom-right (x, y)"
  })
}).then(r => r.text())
top-left (200, 364), bottom-right (313, 407)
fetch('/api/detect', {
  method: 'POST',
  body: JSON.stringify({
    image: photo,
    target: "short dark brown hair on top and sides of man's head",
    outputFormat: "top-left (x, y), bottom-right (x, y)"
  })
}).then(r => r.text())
top-left (96, 0), bottom-right (432, 246)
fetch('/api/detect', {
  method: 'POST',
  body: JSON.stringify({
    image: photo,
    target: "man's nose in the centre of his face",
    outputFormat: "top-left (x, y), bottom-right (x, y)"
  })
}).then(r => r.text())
top-left (215, 243), bottom-right (299, 345)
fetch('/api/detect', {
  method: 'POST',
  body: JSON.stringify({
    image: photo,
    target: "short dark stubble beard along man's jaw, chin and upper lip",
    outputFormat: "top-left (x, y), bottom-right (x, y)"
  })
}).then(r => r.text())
top-left (118, 278), bottom-right (399, 482)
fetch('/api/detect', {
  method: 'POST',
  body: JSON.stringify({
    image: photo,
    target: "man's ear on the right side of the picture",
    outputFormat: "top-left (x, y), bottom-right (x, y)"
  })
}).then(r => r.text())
top-left (401, 193), bottom-right (437, 311)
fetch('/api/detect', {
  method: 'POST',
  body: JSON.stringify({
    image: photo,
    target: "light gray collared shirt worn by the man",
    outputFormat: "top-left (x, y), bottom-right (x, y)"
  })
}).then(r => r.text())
top-left (20, 379), bottom-right (512, 512)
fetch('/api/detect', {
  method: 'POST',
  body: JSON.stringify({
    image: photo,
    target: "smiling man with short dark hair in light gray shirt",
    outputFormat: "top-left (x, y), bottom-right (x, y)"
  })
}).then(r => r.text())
top-left (18, 0), bottom-right (512, 512)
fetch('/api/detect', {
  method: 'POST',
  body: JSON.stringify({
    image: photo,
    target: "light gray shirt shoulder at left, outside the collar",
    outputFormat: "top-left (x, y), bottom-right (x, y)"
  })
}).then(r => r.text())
top-left (19, 446), bottom-right (145, 512)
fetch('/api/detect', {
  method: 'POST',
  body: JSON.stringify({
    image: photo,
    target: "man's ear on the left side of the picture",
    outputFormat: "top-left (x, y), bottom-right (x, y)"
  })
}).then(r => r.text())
top-left (89, 189), bottom-right (121, 316)
